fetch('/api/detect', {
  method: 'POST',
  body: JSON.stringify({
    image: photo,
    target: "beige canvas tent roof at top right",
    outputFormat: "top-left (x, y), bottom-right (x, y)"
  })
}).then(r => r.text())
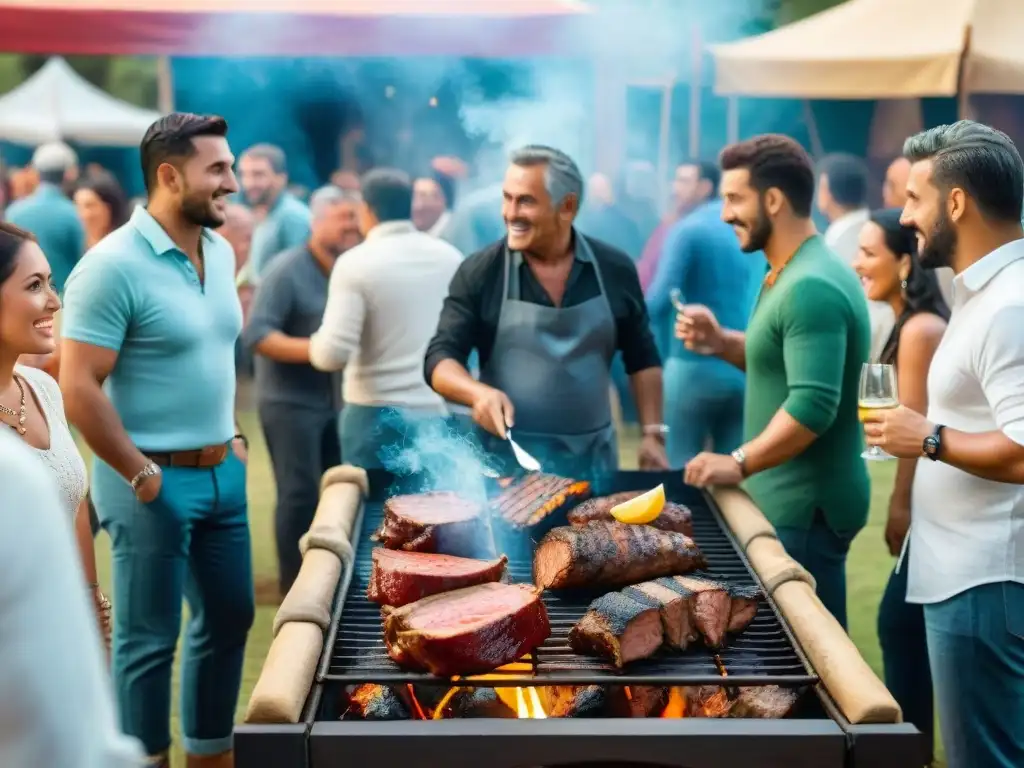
top-left (712, 0), bottom-right (1024, 98)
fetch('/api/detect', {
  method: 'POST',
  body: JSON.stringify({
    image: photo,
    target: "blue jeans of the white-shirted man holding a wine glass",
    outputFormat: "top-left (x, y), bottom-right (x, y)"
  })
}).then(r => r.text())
top-left (925, 582), bottom-right (1024, 768)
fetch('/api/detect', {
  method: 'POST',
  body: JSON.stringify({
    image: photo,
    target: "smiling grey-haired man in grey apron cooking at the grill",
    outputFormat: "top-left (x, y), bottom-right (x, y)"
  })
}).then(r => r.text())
top-left (425, 146), bottom-right (667, 477)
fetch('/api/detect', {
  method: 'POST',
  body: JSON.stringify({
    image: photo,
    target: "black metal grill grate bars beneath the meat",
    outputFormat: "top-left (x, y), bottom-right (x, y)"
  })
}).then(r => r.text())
top-left (323, 472), bottom-right (817, 686)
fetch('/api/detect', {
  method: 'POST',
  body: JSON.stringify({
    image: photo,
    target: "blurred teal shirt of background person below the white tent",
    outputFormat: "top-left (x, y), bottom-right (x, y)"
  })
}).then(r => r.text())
top-left (6, 182), bottom-right (85, 292)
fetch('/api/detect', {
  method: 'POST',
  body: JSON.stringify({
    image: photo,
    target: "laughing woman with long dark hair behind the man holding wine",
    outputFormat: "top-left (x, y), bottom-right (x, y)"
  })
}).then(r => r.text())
top-left (853, 208), bottom-right (949, 762)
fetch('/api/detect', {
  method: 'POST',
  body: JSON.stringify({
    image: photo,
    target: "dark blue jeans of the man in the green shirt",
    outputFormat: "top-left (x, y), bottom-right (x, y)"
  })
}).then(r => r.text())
top-left (775, 510), bottom-right (859, 630)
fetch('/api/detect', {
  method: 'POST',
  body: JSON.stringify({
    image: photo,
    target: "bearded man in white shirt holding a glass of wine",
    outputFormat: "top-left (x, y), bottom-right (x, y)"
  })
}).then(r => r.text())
top-left (865, 121), bottom-right (1024, 768)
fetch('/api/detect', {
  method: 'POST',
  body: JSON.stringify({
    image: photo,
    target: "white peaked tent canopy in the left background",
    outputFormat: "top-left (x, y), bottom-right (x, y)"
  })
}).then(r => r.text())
top-left (0, 56), bottom-right (160, 146)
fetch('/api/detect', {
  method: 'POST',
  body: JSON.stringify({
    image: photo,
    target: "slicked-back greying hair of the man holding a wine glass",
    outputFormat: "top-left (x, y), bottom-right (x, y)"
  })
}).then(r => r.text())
top-left (903, 120), bottom-right (1024, 222)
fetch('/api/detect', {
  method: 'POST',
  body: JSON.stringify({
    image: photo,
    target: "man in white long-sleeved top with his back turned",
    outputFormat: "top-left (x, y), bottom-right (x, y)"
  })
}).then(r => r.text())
top-left (309, 168), bottom-right (462, 469)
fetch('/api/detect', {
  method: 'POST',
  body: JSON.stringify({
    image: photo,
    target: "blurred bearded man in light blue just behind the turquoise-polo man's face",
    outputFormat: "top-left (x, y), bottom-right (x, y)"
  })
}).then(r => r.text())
top-left (239, 144), bottom-right (309, 286)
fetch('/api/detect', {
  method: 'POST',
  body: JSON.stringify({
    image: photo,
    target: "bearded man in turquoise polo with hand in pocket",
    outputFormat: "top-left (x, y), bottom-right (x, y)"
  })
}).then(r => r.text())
top-left (60, 113), bottom-right (254, 768)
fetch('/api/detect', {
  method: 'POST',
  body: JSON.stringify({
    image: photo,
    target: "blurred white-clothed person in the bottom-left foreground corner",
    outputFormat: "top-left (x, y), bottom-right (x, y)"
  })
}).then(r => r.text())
top-left (0, 436), bottom-right (143, 768)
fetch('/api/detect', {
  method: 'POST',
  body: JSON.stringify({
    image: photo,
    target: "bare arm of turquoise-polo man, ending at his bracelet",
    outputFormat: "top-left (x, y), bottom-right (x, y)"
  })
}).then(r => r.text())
top-left (60, 339), bottom-right (150, 482)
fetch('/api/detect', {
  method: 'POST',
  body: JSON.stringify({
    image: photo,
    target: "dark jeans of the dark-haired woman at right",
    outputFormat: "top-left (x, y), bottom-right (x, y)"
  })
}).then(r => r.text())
top-left (879, 550), bottom-right (935, 762)
